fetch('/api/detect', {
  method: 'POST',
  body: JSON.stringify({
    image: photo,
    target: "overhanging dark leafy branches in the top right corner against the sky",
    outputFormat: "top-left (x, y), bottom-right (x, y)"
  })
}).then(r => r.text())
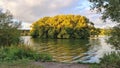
top-left (89, 0), bottom-right (120, 22)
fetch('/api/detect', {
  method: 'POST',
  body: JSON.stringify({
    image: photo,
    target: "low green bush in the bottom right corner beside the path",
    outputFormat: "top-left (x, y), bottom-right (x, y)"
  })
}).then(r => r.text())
top-left (91, 52), bottom-right (120, 68)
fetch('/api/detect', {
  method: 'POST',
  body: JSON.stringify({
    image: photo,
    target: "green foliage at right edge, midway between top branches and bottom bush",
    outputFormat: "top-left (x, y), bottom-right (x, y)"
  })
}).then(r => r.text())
top-left (107, 25), bottom-right (120, 49)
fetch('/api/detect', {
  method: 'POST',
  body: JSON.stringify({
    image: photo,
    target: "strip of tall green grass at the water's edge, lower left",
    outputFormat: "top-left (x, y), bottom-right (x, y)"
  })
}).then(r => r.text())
top-left (0, 45), bottom-right (52, 62)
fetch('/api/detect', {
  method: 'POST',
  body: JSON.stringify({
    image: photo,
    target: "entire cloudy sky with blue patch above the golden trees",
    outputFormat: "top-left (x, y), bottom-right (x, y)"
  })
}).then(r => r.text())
top-left (0, 0), bottom-right (115, 29)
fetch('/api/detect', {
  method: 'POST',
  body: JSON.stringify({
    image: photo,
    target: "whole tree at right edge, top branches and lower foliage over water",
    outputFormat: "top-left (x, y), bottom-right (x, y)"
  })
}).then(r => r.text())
top-left (89, 0), bottom-right (120, 48)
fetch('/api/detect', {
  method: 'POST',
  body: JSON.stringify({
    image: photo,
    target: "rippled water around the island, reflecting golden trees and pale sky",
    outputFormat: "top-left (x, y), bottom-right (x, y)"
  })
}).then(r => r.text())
top-left (22, 36), bottom-right (114, 63)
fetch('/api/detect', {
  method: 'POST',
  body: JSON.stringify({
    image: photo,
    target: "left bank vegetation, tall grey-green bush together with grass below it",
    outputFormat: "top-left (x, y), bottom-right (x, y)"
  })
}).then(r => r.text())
top-left (0, 10), bottom-right (52, 64)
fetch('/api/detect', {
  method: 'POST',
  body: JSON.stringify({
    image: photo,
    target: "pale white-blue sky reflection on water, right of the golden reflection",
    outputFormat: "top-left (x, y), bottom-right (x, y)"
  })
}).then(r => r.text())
top-left (79, 37), bottom-right (115, 63)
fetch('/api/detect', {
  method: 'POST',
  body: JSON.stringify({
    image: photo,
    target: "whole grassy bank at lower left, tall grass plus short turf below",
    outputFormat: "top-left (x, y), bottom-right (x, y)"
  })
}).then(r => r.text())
top-left (0, 45), bottom-right (52, 68)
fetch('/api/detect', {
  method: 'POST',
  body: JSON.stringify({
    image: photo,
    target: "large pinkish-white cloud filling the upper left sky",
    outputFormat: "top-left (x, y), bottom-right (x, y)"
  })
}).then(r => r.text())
top-left (0, 0), bottom-right (77, 22)
